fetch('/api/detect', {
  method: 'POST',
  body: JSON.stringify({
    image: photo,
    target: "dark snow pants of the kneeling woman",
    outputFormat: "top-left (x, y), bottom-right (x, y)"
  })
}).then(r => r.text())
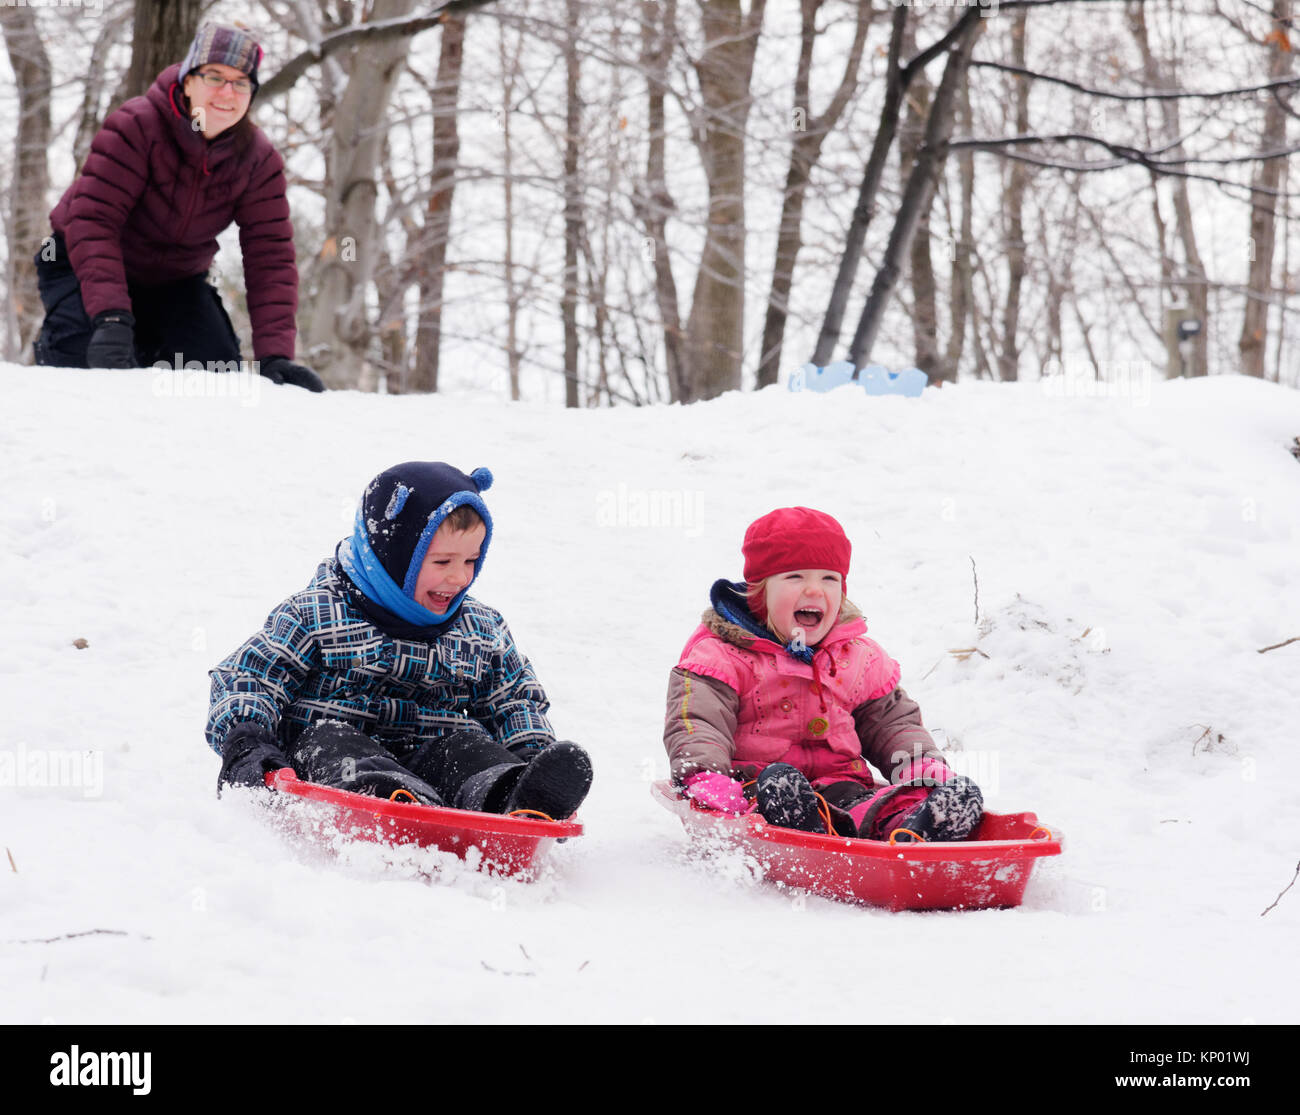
top-left (34, 237), bottom-right (239, 372)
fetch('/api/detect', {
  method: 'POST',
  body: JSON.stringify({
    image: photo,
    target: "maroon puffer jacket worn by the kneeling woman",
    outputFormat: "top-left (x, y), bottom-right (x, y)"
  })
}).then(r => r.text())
top-left (49, 65), bottom-right (298, 360)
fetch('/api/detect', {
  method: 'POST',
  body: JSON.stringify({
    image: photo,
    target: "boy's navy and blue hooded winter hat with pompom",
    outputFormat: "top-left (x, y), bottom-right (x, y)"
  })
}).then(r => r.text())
top-left (339, 461), bottom-right (491, 624)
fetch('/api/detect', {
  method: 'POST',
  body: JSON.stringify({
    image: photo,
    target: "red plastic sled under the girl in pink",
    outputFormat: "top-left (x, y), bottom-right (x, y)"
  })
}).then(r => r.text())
top-left (650, 782), bottom-right (1062, 911)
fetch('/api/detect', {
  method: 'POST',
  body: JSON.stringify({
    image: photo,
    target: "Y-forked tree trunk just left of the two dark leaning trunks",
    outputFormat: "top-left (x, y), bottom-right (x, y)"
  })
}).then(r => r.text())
top-left (758, 0), bottom-right (872, 387)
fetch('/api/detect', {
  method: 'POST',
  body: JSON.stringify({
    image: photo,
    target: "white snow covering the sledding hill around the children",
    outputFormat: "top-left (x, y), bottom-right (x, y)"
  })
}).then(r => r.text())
top-left (0, 365), bottom-right (1300, 1024)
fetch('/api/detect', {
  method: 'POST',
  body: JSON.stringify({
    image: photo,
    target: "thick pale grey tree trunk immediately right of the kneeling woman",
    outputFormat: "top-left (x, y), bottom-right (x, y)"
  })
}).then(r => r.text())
top-left (304, 0), bottom-right (415, 389)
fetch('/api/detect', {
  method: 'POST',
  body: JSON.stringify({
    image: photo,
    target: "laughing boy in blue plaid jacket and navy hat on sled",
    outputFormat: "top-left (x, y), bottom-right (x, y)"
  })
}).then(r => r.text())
top-left (207, 461), bottom-right (592, 820)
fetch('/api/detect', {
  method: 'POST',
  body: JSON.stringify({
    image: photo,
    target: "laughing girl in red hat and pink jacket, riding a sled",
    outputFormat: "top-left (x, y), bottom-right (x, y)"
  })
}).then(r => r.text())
top-left (664, 507), bottom-right (983, 841)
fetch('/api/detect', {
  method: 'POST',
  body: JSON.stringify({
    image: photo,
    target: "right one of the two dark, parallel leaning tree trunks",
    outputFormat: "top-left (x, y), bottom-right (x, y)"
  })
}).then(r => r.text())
top-left (849, 10), bottom-right (983, 368)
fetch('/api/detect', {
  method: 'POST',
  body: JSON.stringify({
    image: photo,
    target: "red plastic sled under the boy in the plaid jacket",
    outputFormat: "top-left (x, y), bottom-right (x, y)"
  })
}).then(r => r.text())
top-left (267, 767), bottom-right (582, 878)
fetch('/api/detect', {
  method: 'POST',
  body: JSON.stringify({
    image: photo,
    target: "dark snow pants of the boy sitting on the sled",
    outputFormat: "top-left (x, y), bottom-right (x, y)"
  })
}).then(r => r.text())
top-left (289, 721), bottom-right (527, 814)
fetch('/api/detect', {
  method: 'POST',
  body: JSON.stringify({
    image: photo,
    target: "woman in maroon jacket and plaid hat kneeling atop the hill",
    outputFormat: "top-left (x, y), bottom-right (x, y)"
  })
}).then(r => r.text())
top-left (35, 25), bottom-right (325, 391)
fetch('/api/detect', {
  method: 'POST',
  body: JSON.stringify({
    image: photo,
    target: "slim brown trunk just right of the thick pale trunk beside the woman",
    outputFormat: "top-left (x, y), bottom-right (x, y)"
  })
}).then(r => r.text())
top-left (408, 6), bottom-right (465, 391)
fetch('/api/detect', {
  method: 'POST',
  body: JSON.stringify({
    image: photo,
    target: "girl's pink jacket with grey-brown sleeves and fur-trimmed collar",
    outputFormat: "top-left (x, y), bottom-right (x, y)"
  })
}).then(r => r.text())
top-left (664, 606), bottom-right (939, 786)
